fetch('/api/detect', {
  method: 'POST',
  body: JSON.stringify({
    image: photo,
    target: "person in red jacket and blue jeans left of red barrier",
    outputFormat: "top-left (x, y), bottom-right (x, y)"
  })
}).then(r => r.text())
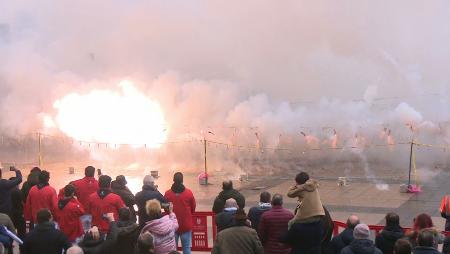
top-left (164, 172), bottom-right (196, 254)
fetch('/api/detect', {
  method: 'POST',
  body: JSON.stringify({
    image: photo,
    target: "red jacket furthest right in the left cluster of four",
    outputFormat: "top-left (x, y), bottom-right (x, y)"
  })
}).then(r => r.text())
top-left (86, 189), bottom-right (125, 233)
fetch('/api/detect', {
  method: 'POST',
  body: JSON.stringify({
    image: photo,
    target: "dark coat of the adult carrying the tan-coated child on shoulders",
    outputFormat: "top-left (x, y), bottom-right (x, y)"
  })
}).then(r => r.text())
top-left (281, 220), bottom-right (323, 254)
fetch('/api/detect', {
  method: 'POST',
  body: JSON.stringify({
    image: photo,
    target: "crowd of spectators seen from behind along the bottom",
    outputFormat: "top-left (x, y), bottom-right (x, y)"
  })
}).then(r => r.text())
top-left (0, 166), bottom-right (450, 254)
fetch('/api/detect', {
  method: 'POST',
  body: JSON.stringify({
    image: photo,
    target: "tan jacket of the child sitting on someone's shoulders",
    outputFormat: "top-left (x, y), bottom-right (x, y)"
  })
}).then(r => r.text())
top-left (287, 179), bottom-right (325, 221)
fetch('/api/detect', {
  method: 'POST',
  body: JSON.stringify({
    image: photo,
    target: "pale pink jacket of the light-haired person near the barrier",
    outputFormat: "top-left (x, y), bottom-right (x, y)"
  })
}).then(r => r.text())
top-left (141, 213), bottom-right (178, 254)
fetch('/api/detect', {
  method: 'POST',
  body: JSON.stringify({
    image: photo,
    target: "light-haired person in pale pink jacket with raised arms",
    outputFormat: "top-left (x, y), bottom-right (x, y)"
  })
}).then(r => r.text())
top-left (141, 199), bottom-right (178, 254)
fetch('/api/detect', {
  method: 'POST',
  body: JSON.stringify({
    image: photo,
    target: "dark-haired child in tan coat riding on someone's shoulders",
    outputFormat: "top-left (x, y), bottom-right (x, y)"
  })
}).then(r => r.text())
top-left (287, 172), bottom-right (325, 225)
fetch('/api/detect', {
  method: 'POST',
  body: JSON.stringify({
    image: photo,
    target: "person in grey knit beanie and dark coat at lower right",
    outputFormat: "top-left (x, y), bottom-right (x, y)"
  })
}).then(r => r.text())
top-left (341, 224), bottom-right (383, 254)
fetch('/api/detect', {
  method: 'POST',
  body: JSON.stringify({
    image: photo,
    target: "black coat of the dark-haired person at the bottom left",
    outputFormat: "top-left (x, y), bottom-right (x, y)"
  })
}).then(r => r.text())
top-left (20, 222), bottom-right (71, 254)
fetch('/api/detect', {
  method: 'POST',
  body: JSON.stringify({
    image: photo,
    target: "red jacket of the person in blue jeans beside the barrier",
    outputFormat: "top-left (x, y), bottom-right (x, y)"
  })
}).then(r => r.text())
top-left (164, 186), bottom-right (196, 233)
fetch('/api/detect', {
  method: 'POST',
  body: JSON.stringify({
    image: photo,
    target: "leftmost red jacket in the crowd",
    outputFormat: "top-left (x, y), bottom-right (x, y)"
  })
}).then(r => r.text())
top-left (23, 184), bottom-right (58, 223)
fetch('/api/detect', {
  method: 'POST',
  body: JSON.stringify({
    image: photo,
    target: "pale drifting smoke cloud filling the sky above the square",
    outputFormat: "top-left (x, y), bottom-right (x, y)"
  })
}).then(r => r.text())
top-left (0, 0), bottom-right (450, 177)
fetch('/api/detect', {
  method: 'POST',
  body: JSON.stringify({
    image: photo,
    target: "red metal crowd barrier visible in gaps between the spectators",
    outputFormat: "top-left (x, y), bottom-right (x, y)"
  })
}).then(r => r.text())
top-left (184, 212), bottom-right (450, 251)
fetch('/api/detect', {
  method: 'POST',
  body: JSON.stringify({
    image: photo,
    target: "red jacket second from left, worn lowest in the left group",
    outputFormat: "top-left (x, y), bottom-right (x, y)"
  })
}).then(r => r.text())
top-left (57, 198), bottom-right (84, 242)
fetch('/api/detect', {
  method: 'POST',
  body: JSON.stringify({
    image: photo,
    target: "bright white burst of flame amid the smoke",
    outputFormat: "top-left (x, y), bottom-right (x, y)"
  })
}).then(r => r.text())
top-left (47, 81), bottom-right (167, 148)
